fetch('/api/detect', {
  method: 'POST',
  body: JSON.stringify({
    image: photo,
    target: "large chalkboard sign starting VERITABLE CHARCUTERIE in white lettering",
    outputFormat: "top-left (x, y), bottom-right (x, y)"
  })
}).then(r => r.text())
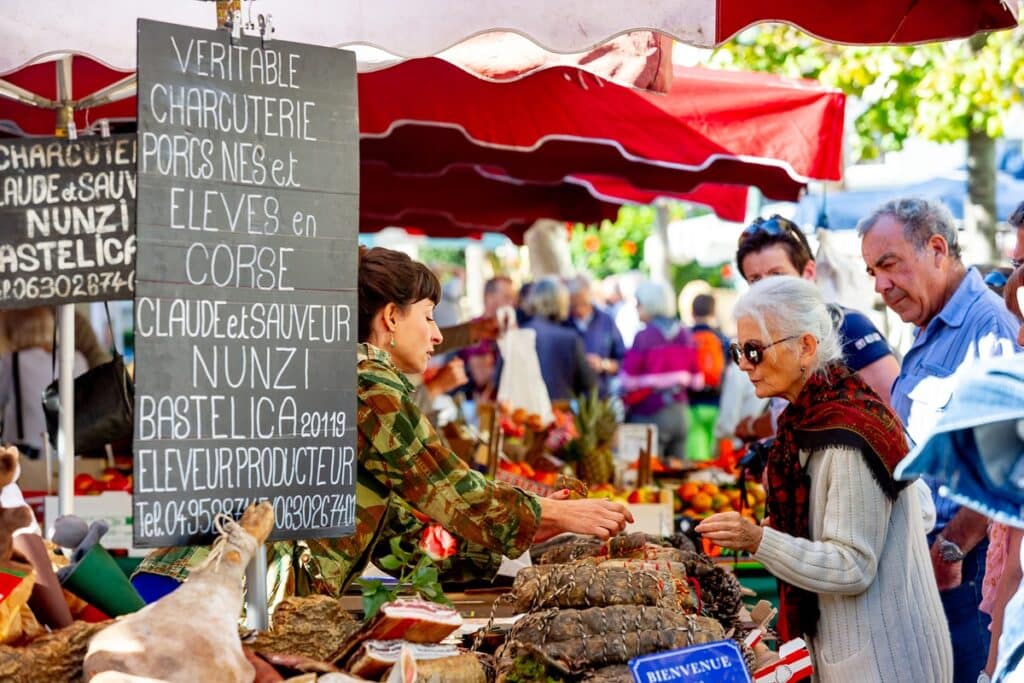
top-left (134, 20), bottom-right (358, 547)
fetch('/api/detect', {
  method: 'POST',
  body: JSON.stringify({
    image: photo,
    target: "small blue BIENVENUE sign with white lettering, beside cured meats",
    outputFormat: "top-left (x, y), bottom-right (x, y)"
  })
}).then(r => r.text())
top-left (630, 640), bottom-right (751, 683)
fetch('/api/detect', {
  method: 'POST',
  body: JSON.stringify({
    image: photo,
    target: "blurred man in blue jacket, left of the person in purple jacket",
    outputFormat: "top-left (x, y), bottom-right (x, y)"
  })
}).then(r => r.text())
top-left (564, 274), bottom-right (626, 397)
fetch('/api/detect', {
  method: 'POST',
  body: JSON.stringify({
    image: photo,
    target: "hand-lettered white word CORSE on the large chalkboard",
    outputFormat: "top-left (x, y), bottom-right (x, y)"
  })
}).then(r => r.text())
top-left (185, 242), bottom-right (295, 292)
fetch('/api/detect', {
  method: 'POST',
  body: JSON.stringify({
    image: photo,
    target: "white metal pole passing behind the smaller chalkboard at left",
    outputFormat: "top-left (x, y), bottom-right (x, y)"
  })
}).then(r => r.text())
top-left (56, 55), bottom-right (76, 515)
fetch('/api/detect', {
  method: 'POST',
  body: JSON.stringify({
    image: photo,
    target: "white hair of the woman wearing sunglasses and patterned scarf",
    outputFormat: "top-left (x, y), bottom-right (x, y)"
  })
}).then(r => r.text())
top-left (732, 275), bottom-right (843, 373)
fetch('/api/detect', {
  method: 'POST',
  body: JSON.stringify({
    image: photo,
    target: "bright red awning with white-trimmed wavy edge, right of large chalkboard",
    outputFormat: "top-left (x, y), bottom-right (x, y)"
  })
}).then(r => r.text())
top-left (359, 58), bottom-right (845, 200)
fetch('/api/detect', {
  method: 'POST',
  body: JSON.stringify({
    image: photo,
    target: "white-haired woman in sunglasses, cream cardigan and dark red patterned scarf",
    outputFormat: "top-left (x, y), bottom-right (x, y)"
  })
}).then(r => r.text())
top-left (697, 275), bottom-right (952, 683)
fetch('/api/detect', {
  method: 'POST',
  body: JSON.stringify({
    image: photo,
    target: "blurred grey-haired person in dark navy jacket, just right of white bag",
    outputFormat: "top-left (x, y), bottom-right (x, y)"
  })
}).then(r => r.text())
top-left (522, 276), bottom-right (597, 400)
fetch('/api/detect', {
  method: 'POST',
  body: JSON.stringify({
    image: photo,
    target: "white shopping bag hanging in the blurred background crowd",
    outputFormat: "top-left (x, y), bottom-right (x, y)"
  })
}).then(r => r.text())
top-left (498, 315), bottom-right (555, 425)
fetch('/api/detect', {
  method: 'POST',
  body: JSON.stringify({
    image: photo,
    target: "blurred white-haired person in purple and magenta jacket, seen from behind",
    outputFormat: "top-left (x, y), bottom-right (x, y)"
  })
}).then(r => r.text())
top-left (622, 281), bottom-right (703, 459)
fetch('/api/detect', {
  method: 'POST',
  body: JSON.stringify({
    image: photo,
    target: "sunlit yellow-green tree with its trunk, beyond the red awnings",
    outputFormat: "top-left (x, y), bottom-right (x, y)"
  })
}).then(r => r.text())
top-left (712, 25), bottom-right (1024, 257)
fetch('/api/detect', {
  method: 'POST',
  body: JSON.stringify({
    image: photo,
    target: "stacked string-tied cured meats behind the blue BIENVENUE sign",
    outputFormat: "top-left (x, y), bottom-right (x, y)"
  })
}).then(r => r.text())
top-left (483, 533), bottom-right (753, 683)
